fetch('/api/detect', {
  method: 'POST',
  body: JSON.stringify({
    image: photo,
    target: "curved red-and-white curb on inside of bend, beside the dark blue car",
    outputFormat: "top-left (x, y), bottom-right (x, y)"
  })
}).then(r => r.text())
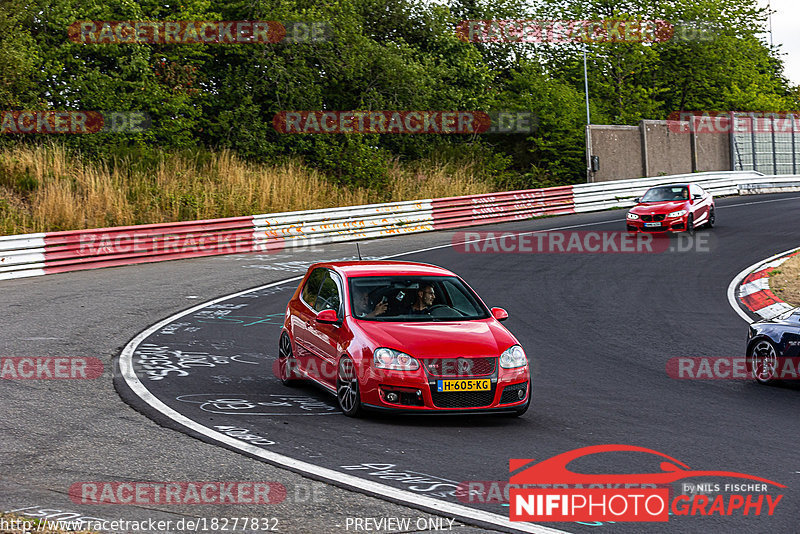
top-left (728, 247), bottom-right (800, 323)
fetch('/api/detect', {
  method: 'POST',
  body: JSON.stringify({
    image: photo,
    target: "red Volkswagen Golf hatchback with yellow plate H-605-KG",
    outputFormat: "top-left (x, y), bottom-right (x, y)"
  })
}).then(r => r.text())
top-left (277, 261), bottom-right (531, 417)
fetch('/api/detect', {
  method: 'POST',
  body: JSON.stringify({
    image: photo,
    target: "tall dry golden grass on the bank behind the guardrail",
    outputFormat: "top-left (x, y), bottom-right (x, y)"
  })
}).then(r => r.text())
top-left (0, 144), bottom-right (492, 234)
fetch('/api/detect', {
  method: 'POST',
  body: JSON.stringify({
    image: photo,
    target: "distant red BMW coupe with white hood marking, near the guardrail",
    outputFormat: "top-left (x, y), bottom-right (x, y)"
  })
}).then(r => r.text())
top-left (626, 184), bottom-right (716, 232)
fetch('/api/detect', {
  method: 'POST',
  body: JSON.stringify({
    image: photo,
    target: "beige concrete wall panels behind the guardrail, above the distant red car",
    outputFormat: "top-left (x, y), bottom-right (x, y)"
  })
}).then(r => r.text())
top-left (589, 121), bottom-right (733, 182)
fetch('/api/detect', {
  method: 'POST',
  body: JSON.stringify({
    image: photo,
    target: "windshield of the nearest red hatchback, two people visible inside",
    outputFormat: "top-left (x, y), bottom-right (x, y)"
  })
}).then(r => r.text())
top-left (349, 276), bottom-right (490, 322)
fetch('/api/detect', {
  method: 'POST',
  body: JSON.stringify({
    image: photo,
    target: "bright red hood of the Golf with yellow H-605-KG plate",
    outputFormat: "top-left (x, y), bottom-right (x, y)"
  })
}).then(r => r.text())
top-left (357, 319), bottom-right (517, 358)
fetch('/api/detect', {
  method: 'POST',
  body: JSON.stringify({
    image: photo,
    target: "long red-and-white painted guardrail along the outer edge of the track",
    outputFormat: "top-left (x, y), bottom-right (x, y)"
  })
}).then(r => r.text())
top-left (0, 171), bottom-right (800, 280)
